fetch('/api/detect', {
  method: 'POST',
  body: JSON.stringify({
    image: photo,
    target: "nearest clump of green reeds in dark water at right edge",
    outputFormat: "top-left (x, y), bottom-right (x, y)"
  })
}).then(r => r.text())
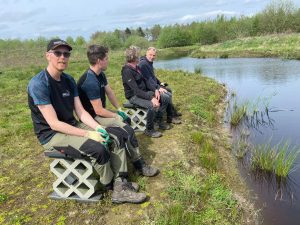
top-left (251, 142), bottom-right (299, 178)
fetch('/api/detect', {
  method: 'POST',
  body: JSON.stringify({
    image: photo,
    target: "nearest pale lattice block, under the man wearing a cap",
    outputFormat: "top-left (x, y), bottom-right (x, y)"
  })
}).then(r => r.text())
top-left (50, 159), bottom-right (100, 200)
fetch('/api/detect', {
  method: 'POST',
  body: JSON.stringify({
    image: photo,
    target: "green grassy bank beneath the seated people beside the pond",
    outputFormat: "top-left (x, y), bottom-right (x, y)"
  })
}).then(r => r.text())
top-left (0, 39), bottom-right (264, 225)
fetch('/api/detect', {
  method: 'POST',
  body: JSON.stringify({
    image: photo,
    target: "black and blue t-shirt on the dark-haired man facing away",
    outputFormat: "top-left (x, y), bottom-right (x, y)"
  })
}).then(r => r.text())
top-left (77, 69), bottom-right (108, 117)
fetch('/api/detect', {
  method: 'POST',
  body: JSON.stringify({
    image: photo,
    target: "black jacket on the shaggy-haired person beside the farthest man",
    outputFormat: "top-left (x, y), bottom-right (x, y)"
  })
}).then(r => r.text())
top-left (122, 64), bottom-right (155, 100)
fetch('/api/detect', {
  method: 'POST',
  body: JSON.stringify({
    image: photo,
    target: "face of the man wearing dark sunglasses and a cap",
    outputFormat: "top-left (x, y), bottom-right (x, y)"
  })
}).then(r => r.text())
top-left (46, 46), bottom-right (71, 72)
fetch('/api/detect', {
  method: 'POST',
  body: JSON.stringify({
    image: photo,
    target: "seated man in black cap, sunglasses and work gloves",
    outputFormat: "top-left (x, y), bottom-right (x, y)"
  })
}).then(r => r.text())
top-left (27, 39), bottom-right (146, 203)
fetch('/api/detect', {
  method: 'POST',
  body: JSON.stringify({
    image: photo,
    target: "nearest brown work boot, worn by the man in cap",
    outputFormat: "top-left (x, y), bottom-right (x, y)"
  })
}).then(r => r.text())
top-left (112, 179), bottom-right (147, 203)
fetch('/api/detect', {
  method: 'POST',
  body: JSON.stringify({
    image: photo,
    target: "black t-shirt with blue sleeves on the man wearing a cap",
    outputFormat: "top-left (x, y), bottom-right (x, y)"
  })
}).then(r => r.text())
top-left (27, 70), bottom-right (78, 144)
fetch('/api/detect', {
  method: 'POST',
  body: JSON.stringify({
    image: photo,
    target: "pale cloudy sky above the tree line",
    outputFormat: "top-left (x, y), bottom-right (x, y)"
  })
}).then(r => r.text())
top-left (0, 0), bottom-right (300, 40)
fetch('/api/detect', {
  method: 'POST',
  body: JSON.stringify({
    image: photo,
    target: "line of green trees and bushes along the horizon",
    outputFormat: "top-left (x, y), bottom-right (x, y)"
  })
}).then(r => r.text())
top-left (0, 0), bottom-right (300, 50)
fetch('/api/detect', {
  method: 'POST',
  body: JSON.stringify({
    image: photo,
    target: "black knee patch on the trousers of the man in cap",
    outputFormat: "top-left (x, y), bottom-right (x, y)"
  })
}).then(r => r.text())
top-left (79, 139), bottom-right (110, 165)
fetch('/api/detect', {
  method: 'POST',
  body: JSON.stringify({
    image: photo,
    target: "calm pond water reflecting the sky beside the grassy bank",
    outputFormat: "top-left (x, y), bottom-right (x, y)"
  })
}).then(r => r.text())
top-left (154, 57), bottom-right (300, 225)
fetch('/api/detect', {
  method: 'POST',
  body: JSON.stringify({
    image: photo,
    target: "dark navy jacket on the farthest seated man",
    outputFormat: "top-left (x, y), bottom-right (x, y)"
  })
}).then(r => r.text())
top-left (139, 56), bottom-right (160, 89)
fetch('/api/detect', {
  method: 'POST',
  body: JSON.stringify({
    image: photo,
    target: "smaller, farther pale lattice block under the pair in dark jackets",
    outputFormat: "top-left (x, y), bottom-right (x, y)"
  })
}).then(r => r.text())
top-left (125, 108), bottom-right (147, 131)
